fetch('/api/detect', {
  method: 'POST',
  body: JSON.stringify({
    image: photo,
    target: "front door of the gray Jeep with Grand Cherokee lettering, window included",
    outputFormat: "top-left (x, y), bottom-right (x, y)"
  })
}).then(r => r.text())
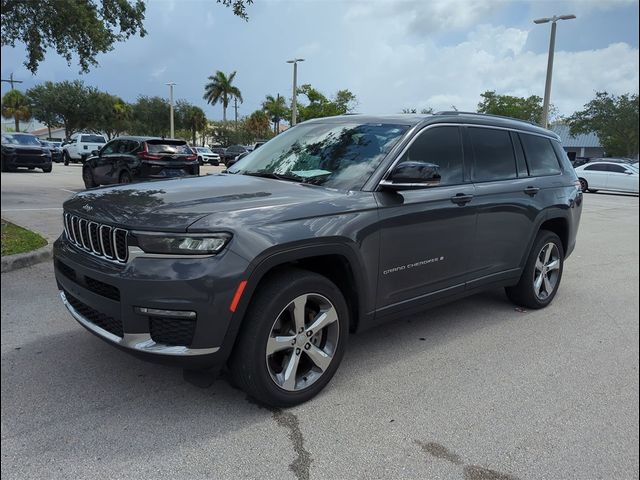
top-left (376, 126), bottom-right (476, 313)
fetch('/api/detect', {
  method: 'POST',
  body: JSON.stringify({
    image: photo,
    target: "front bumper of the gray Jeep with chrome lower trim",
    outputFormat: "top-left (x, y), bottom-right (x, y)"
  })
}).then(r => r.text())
top-left (54, 234), bottom-right (247, 368)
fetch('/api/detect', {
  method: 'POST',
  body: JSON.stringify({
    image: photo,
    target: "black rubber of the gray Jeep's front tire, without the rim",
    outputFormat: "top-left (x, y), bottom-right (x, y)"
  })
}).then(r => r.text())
top-left (239, 274), bottom-right (349, 406)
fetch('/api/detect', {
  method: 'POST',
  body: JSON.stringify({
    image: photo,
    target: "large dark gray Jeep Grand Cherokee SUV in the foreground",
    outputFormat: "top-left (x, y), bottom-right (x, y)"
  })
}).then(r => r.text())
top-left (54, 112), bottom-right (582, 406)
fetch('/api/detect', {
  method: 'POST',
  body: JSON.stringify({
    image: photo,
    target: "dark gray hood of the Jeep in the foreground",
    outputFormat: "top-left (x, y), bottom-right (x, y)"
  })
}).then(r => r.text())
top-left (64, 174), bottom-right (358, 232)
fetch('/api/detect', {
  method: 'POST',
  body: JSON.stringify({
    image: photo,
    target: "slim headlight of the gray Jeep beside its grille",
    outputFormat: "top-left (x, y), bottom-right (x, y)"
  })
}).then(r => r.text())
top-left (135, 233), bottom-right (231, 255)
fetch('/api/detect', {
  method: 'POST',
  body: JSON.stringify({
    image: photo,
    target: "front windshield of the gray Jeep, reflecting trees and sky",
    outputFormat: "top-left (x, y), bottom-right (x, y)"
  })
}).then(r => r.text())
top-left (228, 122), bottom-right (409, 190)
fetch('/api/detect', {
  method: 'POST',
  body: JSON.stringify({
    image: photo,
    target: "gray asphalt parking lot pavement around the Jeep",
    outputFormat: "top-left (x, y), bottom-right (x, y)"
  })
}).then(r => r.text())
top-left (1, 165), bottom-right (639, 480)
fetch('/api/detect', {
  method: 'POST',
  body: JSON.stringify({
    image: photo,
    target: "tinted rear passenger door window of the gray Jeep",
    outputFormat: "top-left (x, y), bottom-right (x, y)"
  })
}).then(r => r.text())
top-left (469, 127), bottom-right (517, 182)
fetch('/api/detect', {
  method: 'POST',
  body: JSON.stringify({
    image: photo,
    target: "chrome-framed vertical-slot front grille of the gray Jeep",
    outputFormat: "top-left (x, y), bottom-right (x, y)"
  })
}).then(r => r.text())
top-left (64, 213), bottom-right (129, 263)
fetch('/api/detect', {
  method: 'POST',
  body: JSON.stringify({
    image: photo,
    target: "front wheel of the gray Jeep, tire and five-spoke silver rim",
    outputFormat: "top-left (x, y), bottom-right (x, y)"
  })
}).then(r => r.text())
top-left (229, 269), bottom-right (349, 408)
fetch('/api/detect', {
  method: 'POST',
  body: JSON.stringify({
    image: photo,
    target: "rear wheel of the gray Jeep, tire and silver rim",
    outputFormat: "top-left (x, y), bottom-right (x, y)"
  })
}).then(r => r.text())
top-left (505, 230), bottom-right (564, 309)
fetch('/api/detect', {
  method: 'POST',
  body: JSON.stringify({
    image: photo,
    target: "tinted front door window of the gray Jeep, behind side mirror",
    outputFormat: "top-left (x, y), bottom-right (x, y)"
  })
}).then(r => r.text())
top-left (400, 127), bottom-right (464, 185)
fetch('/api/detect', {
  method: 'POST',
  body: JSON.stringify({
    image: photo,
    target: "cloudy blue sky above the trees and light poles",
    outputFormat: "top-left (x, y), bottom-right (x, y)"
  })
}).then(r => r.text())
top-left (1, 0), bottom-right (639, 119)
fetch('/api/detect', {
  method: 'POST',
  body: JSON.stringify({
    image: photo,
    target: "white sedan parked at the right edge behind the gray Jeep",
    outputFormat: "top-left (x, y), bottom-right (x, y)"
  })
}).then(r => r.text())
top-left (576, 161), bottom-right (638, 193)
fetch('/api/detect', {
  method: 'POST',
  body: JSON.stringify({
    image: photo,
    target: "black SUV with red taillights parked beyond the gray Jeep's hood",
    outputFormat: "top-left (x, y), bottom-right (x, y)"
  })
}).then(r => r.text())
top-left (82, 137), bottom-right (200, 188)
